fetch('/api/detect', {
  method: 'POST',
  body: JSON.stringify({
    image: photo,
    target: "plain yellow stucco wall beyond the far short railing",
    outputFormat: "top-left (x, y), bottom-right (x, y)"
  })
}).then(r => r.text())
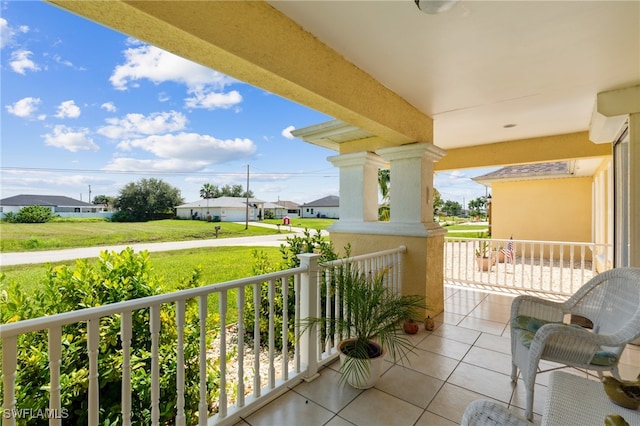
top-left (491, 177), bottom-right (592, 242)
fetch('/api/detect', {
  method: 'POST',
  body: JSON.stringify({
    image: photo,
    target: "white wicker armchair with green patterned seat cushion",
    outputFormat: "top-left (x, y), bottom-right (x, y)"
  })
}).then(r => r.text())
top-left (510, 268), bottom-right (640, 420)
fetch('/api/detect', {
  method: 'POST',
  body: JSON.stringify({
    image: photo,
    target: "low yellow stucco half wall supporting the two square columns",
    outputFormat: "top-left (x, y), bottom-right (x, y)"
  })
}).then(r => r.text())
top-left (331, 232), bottom-right (444, 320)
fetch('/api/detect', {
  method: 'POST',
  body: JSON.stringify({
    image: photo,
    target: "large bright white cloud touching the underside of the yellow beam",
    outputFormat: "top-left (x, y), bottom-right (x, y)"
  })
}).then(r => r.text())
top-left (109, 39), bottom-right (242, 109)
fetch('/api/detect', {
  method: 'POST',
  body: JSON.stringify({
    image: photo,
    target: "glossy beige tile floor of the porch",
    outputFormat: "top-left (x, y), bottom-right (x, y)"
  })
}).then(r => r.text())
top-left (238, 288), bottom-right (640, 426)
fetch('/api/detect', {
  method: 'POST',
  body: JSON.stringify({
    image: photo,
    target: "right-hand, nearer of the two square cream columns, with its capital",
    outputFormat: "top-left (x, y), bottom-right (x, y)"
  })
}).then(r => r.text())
top-left (376, 143), bottom-right (445, 223)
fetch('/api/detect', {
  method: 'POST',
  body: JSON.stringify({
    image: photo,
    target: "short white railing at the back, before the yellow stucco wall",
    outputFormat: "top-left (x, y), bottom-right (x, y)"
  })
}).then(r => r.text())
top-left (444, 237), bottom-right (612, 299)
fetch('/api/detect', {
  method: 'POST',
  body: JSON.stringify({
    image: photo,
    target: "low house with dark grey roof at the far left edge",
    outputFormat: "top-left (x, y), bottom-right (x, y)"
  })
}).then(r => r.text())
top-left (0, 194), bottom-right (113, 218)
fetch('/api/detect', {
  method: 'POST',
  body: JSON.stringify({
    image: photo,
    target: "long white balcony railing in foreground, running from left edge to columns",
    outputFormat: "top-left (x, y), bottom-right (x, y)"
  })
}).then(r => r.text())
top-left (0, 247), bottom-right (406, 426)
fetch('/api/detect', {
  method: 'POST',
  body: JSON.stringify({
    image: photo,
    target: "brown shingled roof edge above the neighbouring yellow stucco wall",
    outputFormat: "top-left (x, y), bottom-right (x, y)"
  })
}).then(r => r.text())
top-left (472, 161), bottom-right (575, 185)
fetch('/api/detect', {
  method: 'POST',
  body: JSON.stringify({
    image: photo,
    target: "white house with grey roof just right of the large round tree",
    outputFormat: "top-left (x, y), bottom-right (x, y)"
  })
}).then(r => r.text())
top-left (176, 197), bottom-right (264, 222)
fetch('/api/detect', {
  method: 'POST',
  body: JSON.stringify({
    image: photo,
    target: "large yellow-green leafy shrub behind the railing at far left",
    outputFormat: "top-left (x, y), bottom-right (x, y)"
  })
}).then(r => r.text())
top-left (0, 248), bottom-right (219, 425)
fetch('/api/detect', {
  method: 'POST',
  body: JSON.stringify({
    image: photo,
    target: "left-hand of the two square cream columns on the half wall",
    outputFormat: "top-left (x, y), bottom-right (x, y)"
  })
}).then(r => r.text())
top-left (328, 152), bottom-right (386, 224)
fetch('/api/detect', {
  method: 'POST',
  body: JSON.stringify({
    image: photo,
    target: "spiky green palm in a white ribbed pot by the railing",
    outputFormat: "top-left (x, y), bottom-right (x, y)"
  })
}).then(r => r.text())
top-left (301, 267), bottom-right (426, 389)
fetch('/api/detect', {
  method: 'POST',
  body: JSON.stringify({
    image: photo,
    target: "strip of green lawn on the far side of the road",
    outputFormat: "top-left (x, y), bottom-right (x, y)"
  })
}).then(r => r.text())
top-left (0, 219), bottom-right (286, 252)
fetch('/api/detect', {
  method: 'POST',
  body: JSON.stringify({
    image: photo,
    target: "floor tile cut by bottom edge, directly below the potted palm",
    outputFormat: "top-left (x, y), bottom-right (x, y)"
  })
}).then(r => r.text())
top-left (338, 388), bottom-right (423, 426)
